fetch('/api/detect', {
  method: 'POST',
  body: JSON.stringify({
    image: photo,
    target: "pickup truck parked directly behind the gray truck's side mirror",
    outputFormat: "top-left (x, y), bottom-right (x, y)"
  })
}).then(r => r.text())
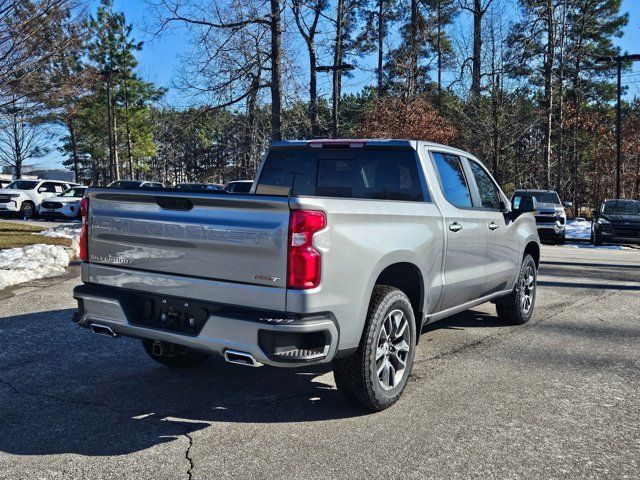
top-left (512, 190), bottom-right (573, 244)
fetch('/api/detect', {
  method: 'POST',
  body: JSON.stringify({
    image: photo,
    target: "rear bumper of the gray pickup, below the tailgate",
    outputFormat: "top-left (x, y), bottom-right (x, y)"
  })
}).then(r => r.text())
top-left (73, 284), bottom-right (339, 367)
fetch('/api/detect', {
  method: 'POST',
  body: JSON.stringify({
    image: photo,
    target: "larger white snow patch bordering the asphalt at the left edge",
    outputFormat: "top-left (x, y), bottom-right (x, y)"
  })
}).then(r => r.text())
top-left (0, 244), bottom-right (70, 290)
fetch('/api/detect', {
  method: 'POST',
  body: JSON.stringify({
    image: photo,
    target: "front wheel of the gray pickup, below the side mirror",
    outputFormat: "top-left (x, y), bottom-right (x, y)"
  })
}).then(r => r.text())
top-left (496, 254), bottom-right (538, 325)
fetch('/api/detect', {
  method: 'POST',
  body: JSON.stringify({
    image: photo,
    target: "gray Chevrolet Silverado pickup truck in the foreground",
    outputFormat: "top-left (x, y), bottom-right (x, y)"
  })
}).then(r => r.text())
top-left (74, 140), bottom-right (540, 411)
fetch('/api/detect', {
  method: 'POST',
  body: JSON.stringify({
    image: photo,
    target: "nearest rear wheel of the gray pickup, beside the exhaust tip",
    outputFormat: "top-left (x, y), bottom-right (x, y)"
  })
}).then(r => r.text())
top-left (333, 285), bottom-right (416, 412)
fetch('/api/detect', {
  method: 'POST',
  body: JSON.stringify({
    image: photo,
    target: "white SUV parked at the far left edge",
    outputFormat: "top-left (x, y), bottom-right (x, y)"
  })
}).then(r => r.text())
top-left (0, 180), bottom-right (77, 218)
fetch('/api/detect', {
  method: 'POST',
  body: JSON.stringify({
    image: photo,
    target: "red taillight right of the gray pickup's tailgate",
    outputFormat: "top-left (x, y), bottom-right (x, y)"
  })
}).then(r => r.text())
top-left (287, 210), bottom-right (327, 290)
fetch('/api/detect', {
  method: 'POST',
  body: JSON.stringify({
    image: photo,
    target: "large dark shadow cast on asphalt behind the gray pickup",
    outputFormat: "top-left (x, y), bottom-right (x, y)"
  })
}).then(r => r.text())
top-left (0, 309), bottom-right (364, 455)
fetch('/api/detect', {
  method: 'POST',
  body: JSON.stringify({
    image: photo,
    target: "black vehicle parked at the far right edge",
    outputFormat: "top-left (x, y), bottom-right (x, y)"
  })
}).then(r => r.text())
top-left (591, 199), bottom-right (640, 245)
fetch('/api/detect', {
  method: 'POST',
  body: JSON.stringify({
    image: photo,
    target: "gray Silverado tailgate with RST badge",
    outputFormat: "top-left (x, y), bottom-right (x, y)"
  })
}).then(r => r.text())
top-left (87, 188), bottom-right (289, 288)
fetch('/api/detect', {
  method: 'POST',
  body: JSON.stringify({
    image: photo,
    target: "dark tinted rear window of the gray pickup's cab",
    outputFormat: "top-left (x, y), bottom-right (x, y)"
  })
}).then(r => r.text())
top-left (256, 148), bottom-right (424, 202)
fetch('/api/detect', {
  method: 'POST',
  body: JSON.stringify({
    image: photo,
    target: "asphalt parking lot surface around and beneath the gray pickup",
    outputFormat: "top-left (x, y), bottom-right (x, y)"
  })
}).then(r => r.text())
top-left (0, 246), bottom-right (640, 479)
